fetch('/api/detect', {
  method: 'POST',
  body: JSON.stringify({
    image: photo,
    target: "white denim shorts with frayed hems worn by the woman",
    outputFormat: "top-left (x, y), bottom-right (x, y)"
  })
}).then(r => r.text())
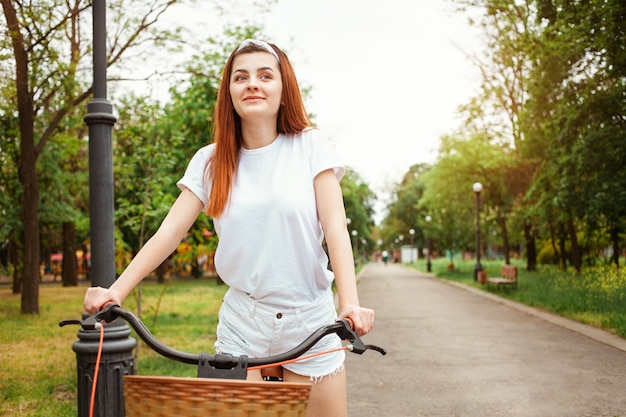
top-left (215, 288), bottom-right (346, 381)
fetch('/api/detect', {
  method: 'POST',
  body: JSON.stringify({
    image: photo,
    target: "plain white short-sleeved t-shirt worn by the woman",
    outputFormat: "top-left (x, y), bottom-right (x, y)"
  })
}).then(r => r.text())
top-left (177, 129), bottom-right (345, 307)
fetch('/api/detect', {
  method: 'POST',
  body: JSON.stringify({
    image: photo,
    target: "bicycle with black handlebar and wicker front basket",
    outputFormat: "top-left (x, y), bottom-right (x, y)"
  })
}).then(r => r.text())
top-left (59, 304), bottom-right (387, 417)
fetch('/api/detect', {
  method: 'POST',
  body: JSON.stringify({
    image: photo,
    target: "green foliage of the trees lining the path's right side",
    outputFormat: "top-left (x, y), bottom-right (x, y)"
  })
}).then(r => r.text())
top-left (383, 0), bottom-right (626, 271)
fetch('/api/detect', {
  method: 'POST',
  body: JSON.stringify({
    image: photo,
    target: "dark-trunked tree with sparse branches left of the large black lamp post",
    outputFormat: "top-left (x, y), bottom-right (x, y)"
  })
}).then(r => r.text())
top-left (0, 0), bottom-right (183, 313)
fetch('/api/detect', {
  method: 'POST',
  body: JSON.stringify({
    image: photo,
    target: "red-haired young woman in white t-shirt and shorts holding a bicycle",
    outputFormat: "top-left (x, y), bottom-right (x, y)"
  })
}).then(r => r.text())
top-left (84, 39), bottom-right (374, 417)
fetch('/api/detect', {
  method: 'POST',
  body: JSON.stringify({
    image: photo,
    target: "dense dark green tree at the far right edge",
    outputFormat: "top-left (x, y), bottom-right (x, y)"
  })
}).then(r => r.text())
top-left (524, 0), bottom-right (626, 271)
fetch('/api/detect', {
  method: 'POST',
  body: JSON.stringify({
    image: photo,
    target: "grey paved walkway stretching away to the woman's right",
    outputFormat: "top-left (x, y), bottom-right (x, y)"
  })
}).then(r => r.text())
top-left (347, 263), bottom-right (626, 417)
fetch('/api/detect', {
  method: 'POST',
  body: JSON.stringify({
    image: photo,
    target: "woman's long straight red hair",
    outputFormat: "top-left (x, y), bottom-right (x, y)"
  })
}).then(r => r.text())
top-left (204, 44), bottom-right (311, 217)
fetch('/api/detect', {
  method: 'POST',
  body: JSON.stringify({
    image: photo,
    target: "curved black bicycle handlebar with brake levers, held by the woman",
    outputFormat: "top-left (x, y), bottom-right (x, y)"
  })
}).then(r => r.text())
top-left (59, 304), bottom-right (387, 378)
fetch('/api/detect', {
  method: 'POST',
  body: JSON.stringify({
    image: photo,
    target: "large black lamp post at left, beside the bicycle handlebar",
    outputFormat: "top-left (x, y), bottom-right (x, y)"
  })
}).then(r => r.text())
top-left (72, 0), bottom-right (137, 417)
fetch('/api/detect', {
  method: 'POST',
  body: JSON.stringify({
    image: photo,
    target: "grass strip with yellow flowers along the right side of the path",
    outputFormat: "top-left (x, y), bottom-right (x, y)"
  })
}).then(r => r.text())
top-left (412, 259), bottom-right (626, 337)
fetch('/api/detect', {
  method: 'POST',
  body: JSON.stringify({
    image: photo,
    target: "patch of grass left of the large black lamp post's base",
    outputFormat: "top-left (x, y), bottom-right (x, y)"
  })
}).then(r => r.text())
top-left (0, 285), bottom-right (85, 417)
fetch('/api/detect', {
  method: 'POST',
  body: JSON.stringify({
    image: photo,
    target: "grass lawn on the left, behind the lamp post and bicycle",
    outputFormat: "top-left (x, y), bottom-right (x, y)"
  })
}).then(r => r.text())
top-left (0, 279), bottom-right (226, 417)
